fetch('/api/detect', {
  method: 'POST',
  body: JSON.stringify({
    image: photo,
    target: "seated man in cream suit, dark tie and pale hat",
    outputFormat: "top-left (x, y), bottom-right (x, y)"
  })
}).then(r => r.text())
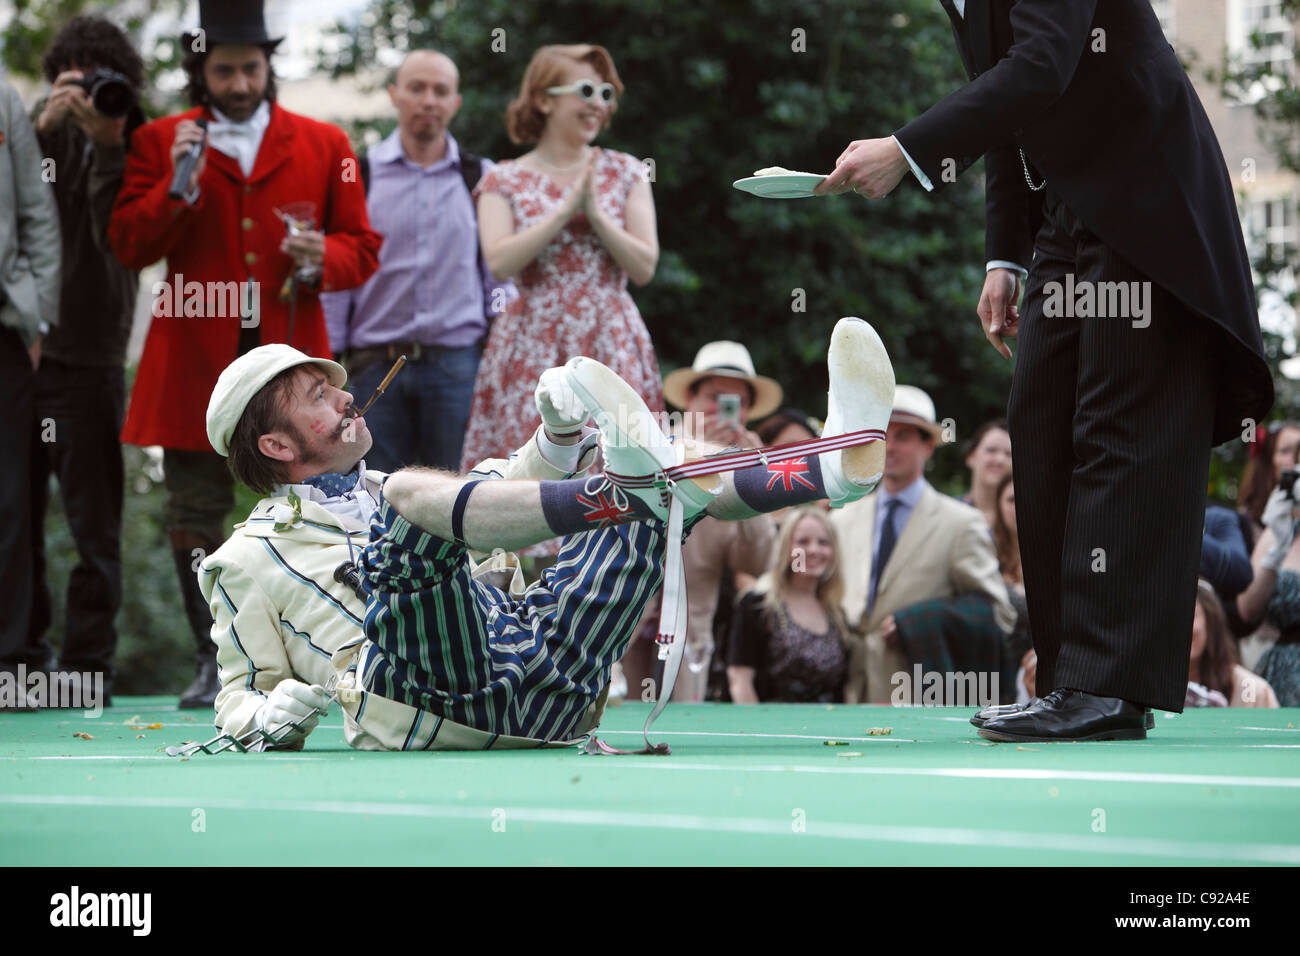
top-left (832, 385), bottom-right (1015, 704)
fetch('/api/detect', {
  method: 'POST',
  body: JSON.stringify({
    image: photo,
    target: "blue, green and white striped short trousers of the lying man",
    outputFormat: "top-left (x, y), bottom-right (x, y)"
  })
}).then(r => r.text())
top-left (358, 502), bottom-right (664, 740)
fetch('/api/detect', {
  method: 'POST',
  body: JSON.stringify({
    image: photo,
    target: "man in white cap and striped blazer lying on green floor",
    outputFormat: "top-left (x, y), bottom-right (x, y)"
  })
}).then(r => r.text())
top-left (200, 319), bottom-right (894, 749)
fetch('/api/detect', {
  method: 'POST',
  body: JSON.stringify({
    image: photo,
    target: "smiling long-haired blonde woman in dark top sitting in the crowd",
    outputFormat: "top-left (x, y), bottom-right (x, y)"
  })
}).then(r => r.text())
top-left (727, 505), bottom-right (849, 704)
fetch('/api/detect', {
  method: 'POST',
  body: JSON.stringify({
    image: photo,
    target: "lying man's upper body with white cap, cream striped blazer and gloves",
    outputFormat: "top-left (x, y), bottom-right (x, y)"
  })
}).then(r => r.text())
top-left (199, 345), bottom-right (597, 749)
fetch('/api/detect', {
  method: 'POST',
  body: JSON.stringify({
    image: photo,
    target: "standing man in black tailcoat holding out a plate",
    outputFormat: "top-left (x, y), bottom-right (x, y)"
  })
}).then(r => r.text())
top-left (818, 0), bottom-right (1273, 740)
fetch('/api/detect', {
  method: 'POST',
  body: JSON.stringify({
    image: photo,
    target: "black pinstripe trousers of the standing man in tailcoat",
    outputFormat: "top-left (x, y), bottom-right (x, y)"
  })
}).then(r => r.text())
top-left (1008, 185), bottom-right (1218, 711)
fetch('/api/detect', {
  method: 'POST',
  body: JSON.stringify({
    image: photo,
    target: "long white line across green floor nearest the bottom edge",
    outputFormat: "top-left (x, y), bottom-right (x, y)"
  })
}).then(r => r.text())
top-left (0, 793), bottom-right (1300, 864)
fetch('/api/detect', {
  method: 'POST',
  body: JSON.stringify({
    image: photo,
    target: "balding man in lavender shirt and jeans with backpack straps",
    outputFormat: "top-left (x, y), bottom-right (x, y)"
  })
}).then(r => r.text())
top-left (321, 49), bottom-right (514, 471)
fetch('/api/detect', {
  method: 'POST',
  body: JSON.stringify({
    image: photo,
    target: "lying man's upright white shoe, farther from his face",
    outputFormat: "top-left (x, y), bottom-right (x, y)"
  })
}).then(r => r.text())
top-left (820, 316), bottom-right (894, 507)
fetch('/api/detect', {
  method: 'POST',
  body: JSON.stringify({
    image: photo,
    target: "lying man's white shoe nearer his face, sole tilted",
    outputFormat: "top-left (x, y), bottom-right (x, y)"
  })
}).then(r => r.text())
top-left (564, 355), bottom-right (723, 520)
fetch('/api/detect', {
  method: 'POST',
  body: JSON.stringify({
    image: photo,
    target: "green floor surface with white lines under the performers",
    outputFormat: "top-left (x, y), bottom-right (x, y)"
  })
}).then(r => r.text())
top-left (0, 697), bottom-right (1300, 866)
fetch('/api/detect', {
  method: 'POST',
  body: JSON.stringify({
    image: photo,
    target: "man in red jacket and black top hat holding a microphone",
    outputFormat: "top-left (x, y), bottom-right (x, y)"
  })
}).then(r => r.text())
top-left (109, 0), bottom-right (382, 708)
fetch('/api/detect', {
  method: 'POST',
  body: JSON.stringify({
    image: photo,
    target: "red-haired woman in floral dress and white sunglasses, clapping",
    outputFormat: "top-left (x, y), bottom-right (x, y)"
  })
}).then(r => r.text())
top-left (463, 44), bottom-right (663, 494)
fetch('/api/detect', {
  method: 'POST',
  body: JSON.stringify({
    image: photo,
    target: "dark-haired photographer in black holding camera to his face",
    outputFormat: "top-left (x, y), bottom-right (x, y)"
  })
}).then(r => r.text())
top-left (29, 17), bottom-right (144, 702)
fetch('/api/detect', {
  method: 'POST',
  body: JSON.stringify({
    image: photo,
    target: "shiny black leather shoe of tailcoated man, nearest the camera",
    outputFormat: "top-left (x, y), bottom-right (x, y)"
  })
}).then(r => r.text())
top-left (979, 687), bottom-right (1147, 743)
